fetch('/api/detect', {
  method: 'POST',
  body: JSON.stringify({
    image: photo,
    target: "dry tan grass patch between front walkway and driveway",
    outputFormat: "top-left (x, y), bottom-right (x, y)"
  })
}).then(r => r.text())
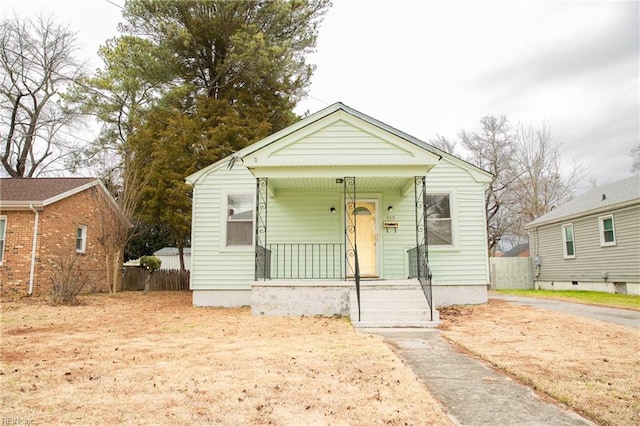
top-left (440, 299), bottom-right (640, 425)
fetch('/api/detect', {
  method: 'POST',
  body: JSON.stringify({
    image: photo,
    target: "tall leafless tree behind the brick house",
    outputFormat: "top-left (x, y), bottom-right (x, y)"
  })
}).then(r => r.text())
top-left (0, 16), bottom-right (83, 178)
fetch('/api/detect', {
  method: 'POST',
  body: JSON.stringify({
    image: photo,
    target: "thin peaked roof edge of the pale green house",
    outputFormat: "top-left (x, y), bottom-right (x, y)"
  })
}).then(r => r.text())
top-left (185, 102), bottom-right (492, 184)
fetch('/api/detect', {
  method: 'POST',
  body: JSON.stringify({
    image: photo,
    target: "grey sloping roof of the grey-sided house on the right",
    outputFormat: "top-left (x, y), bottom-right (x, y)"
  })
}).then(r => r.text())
top-left (526, 175), bottom-right (640, 228)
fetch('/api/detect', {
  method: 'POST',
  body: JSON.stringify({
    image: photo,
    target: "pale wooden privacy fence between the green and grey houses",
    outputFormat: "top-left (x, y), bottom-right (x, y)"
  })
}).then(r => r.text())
top-left (489, 257), bottom-right (534, 290)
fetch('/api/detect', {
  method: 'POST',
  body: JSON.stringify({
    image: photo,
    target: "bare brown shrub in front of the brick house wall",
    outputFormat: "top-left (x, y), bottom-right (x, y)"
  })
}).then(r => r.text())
top-left (49, 256), bottom-right (89, 305)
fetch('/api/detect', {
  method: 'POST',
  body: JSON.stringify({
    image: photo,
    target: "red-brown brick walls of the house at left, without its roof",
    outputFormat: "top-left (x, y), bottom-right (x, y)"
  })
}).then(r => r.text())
top-left (0, 187), bottom-right (108, 299)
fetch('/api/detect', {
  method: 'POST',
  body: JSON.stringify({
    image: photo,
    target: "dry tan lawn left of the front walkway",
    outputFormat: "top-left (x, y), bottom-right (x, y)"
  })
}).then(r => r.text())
top-left (0, 292), bottom-right (450, 425)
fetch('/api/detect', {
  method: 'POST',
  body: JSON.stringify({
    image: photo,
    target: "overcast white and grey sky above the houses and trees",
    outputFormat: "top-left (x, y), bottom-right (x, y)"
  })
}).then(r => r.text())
top-left (2, 0), bottom-right (640, 187)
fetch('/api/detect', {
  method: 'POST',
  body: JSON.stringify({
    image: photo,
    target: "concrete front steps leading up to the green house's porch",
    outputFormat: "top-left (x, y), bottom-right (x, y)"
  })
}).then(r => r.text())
top-left (349, 284), bottom-right (440, 328)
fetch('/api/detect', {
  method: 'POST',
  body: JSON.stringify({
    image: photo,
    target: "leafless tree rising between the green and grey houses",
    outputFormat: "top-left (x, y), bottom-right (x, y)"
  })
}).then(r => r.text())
top-left (456, 116), bottom-right (585, 254)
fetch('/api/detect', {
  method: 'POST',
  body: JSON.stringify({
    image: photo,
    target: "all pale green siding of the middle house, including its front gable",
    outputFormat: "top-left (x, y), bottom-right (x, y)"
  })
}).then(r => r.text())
top-left (191, 107), bottom-right (490, 290)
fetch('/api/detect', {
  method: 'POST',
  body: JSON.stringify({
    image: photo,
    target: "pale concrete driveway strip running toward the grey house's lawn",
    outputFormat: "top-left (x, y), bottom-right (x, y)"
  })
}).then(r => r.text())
top-left (489, 292), bottom-right (640, 328)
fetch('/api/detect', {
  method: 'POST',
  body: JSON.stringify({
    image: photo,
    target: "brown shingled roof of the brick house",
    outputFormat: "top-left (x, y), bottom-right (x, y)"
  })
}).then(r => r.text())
top-left (0, 178), bottom-right (102, 209)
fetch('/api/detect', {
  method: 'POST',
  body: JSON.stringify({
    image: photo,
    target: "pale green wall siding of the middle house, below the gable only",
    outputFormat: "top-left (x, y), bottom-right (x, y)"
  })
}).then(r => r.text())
top-left (191, 161), bottom-right (488, 289)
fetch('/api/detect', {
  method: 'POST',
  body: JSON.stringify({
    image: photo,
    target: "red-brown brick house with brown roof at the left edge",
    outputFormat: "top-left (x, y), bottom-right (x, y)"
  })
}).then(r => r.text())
top-left (0, 178), bottom-right (116, 299)
